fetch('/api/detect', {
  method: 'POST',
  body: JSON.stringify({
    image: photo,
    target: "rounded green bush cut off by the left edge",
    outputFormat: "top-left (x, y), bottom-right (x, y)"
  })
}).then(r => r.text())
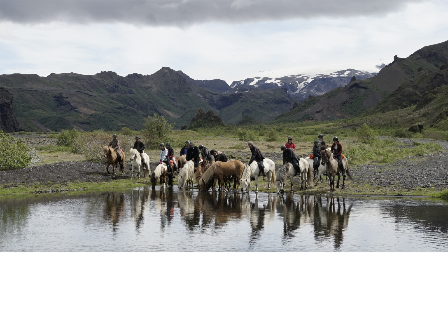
top-left (0, 131), bottom-right (31, 170)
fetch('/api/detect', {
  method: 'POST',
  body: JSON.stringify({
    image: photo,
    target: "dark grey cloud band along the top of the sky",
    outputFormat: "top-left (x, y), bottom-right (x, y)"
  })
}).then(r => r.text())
top-left (0, 0), bottom-right (429, 27)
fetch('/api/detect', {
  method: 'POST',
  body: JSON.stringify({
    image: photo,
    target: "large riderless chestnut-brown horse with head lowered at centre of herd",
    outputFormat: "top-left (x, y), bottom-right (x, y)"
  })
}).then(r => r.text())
top-left (199, 160), bottom-right (246, 190)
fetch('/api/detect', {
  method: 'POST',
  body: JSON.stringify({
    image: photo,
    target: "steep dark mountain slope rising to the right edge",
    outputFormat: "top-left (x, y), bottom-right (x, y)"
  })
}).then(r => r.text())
top-left (277, 41), bottom-right (448, 122)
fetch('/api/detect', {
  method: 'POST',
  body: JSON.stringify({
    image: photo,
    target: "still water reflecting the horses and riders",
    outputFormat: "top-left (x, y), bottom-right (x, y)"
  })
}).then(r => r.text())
top-left (0, 189), bottom-right (448, 252)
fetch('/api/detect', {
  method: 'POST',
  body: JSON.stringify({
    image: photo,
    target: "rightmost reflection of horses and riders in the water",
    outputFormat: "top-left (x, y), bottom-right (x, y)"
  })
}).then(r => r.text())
top-left (314, 198), bottom-right (353, 249)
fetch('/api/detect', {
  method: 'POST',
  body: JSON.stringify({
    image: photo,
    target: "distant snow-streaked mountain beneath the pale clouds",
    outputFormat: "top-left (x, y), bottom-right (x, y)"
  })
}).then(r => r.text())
top-left (230, 69), bottom-right (376, 101)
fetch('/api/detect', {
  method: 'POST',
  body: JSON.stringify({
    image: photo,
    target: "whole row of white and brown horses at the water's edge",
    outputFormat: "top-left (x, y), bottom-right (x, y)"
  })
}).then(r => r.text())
top-left (104, 147), bottom-right (351, 194)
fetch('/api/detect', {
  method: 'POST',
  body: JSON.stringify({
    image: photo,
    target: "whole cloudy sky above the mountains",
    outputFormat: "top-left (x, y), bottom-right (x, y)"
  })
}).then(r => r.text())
top-left (0, 0), bottom-right (448, 83)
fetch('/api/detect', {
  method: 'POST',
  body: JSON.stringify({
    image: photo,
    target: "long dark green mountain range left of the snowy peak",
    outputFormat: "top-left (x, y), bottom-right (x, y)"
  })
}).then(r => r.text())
top-left (0, 68), bottom-right (293, 131)
